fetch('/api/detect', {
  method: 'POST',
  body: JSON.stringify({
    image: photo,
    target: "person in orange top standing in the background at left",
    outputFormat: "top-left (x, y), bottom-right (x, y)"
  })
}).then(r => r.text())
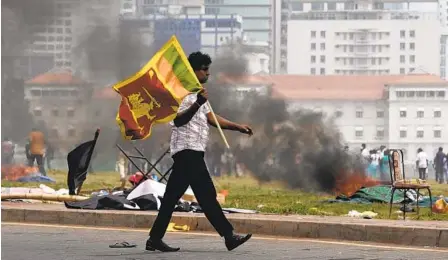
top-left (28, 128), bottom-right (47, 176)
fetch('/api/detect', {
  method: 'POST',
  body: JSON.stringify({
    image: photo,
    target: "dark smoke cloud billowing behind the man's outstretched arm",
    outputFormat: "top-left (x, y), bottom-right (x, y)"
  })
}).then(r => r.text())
top-left (207, 44), bottom-right (364, 192)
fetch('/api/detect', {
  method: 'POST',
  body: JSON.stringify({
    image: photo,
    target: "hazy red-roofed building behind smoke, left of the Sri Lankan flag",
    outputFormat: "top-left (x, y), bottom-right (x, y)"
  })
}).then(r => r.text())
top-left (25, 70), bottom-right (92, 150)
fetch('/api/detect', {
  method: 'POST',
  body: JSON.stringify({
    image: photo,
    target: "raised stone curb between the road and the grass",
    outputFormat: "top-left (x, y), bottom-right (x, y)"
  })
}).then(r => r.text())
top-left (1, 206), bottom-right (448, 248)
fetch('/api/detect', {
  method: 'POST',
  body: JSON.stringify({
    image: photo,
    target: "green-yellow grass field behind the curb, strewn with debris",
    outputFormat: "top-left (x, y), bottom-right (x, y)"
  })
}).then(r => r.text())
top-left (2, 171), bottom-right (448, 220)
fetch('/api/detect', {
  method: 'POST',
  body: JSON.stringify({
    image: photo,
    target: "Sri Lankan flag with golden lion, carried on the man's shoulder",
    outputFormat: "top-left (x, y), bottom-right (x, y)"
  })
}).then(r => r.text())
top-left (113, 36), bottom-right (202, 140)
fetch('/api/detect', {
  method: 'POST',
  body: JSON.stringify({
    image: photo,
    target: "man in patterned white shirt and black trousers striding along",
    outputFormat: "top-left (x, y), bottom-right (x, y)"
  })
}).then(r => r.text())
top-left (146, 52), bottom-right (252, 252)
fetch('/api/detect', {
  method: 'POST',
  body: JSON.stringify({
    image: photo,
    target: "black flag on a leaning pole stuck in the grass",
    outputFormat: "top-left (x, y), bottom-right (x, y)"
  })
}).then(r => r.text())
top-left (67, 129), bottom-right (100, 195)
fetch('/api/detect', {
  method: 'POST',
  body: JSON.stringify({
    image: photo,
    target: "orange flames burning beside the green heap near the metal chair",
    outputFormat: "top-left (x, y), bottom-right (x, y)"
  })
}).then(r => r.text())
top-left (334, 173), bottom-right (380, 197)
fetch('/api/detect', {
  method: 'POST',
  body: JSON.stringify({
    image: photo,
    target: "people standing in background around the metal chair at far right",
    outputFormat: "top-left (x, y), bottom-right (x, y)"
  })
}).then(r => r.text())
top-left (361, 144), bottom-right (448, 184)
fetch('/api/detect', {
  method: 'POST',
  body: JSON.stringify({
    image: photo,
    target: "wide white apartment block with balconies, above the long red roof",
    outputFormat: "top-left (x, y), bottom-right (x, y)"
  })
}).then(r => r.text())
top-left (288, 19), bottom-right (441, 75)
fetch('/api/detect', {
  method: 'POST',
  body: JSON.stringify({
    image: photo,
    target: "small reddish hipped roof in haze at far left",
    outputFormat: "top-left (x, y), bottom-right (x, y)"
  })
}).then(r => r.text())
top-left (26, 71), bottom-right (86, 85)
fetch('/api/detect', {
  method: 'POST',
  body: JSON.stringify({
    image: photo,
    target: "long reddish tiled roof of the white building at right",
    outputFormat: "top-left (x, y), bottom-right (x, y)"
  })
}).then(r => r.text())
top-left (217, 74), bottom-right (448, 100)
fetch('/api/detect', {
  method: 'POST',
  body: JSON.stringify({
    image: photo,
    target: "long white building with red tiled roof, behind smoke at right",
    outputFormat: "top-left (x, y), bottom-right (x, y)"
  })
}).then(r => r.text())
top-left (215, 74), bottom-right (448, 160)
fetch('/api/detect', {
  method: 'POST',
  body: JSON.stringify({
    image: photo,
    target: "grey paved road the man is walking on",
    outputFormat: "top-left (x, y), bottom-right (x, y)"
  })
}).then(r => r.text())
top-left (2, 223), bottom-right (448, 260)
